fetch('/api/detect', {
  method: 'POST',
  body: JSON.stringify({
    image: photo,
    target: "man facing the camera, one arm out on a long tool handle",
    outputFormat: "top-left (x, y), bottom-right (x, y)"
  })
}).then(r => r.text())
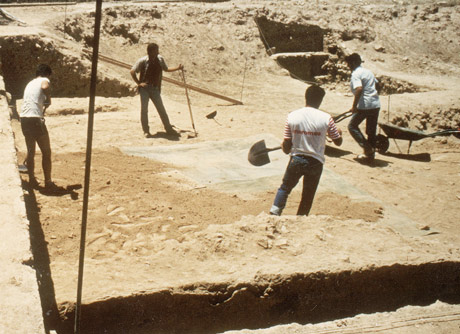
top-left (130, 43), bottom-right (183, 138)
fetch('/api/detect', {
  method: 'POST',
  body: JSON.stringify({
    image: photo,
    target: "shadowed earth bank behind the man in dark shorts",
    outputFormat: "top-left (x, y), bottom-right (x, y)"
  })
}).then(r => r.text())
top-left (0, 35), bottom-right (135, 99)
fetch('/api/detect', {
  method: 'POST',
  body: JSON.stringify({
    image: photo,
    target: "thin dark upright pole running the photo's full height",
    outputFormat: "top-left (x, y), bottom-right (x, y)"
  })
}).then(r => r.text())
top-left (74, 0), bottom-right (102, 334)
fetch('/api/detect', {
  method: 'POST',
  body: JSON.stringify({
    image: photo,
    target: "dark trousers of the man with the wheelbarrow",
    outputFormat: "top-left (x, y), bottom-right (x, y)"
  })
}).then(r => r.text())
top-left (348, 108), bottom-right (380, 152)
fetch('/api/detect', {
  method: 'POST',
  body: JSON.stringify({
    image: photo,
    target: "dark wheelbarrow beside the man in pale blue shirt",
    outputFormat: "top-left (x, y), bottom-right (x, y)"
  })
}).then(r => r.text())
top-left (377, 123), bottom-right (460, 154)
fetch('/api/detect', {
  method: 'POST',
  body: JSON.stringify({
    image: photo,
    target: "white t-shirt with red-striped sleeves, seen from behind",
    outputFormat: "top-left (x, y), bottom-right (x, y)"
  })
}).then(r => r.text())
top-left (284, 107), bottom-right (340, 164)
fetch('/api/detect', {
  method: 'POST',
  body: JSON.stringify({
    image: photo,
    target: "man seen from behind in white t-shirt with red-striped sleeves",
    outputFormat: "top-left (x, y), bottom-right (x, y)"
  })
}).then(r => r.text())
top-left (270, 85), bottom-right (342, 216)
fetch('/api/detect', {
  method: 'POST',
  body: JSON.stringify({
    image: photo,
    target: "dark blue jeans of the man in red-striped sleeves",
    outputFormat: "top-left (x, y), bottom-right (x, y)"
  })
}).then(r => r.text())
top-left (270, 156), bottom-right (323, 216)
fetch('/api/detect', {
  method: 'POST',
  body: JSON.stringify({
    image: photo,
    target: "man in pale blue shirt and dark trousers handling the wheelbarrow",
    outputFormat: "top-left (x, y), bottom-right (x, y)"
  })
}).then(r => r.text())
top-left (345, 53), bottom-right (380, 162)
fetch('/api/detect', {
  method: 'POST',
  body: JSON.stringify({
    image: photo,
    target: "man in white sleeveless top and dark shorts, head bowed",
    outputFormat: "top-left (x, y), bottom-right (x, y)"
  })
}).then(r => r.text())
top-left (19, 64), bottom-right (57, 190)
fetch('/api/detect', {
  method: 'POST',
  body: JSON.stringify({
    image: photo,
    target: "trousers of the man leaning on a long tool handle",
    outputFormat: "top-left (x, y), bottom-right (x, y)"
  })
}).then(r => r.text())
top-left (139, 85), bottom-right (171, 133)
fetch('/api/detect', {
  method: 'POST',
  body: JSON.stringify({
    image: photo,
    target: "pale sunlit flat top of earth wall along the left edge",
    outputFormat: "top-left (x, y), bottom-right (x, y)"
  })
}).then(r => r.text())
top-left (0, 77), bottom-right (45, 334)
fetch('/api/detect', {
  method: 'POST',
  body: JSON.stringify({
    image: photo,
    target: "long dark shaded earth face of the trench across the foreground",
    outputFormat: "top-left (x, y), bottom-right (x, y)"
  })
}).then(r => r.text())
top-left (55, 262), bottom-right (460, 334)
